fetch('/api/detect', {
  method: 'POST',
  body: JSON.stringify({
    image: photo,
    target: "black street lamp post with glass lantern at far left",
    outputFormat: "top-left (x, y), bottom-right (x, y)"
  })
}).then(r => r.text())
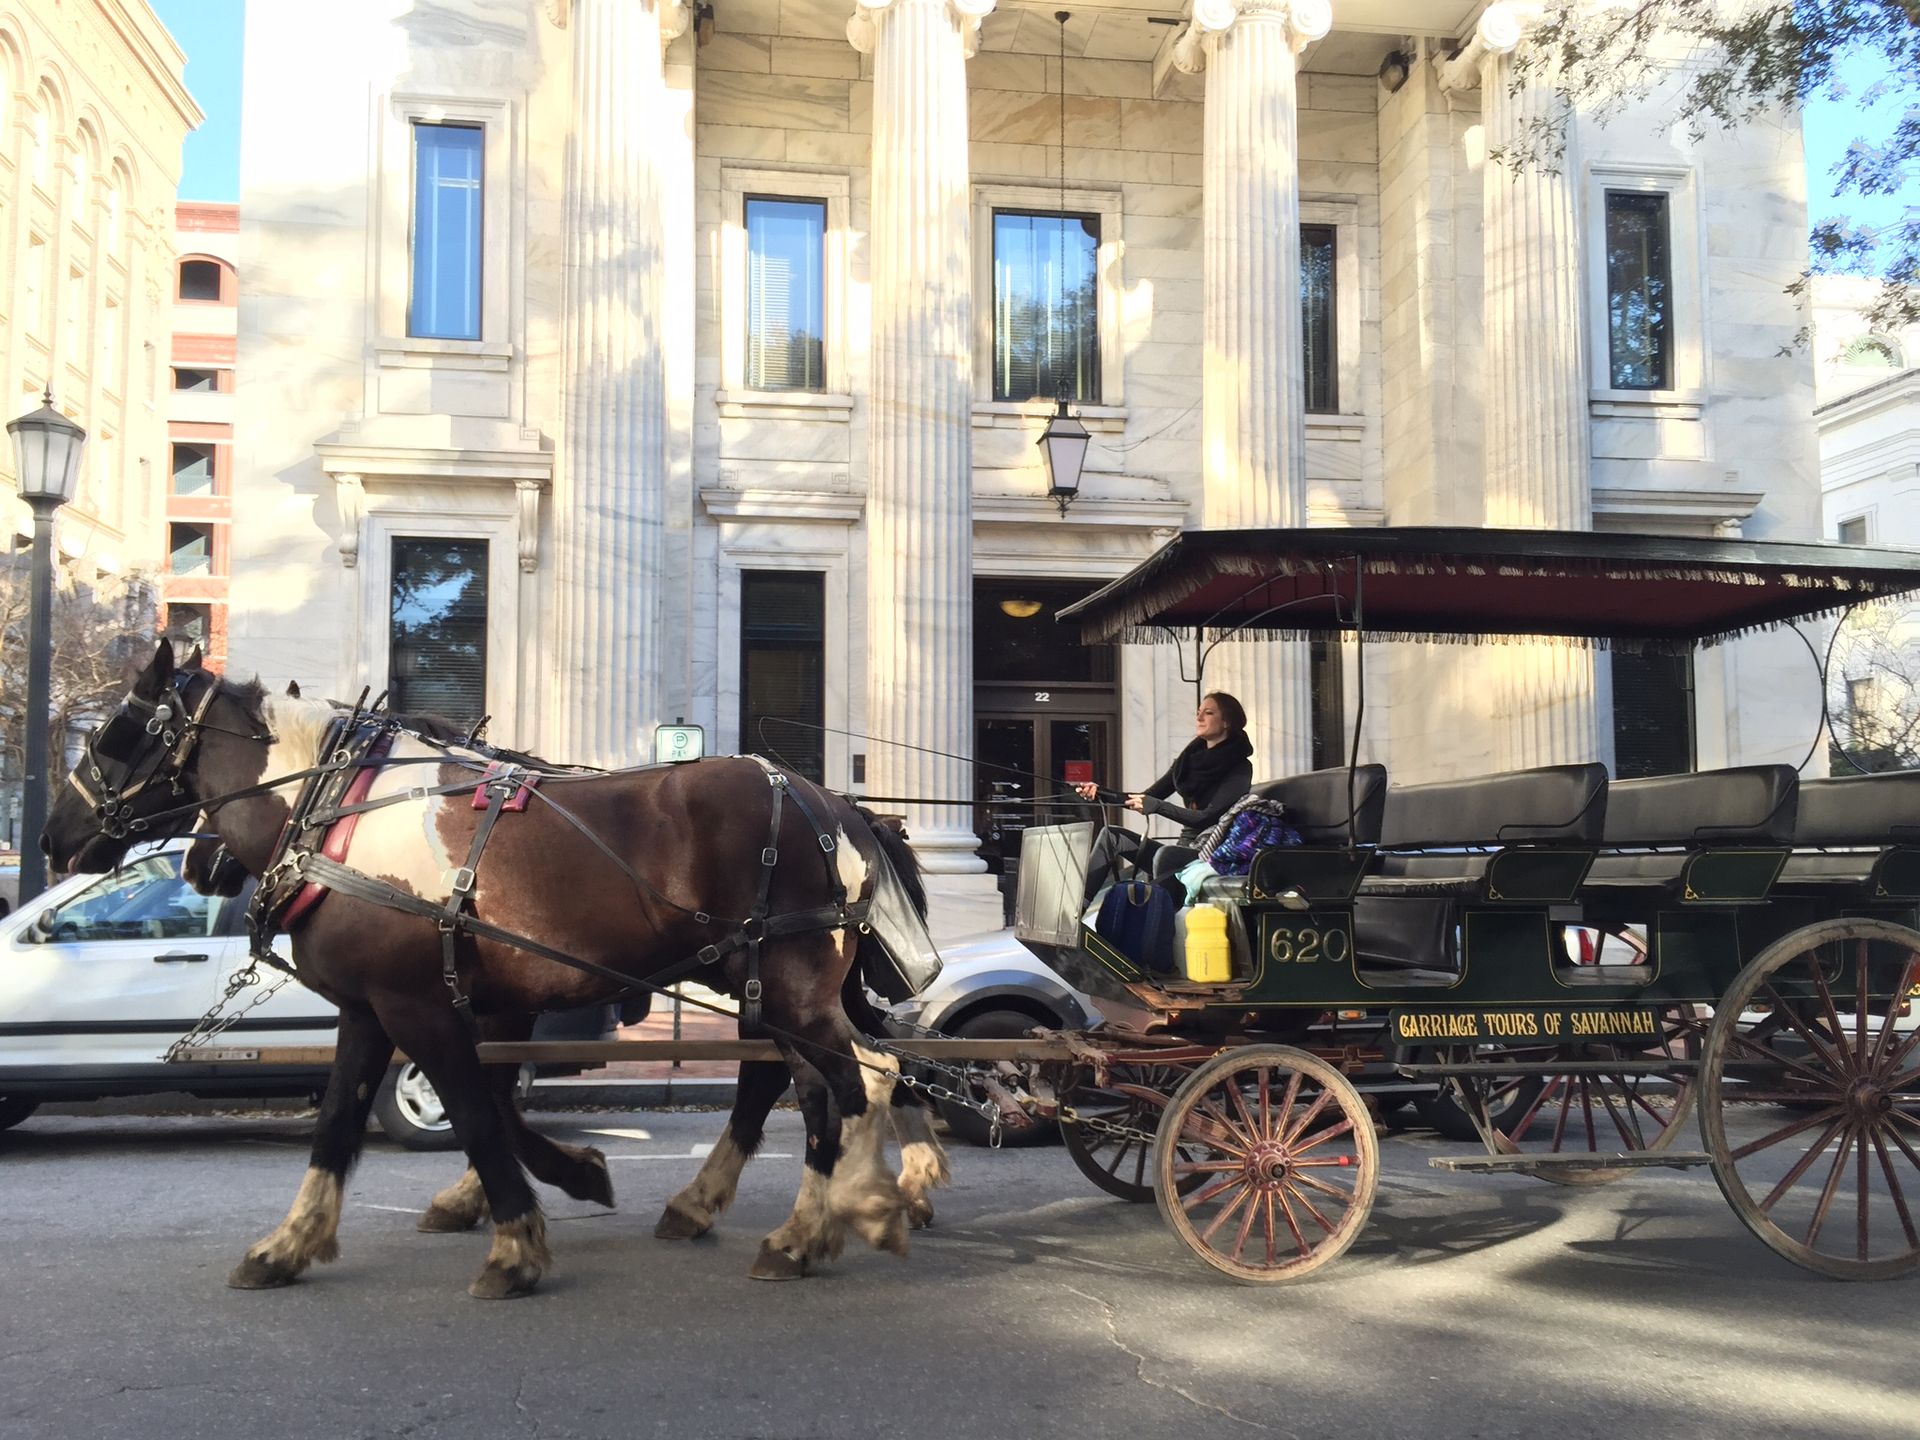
top-left (6, 388), bottom-right (86, 904)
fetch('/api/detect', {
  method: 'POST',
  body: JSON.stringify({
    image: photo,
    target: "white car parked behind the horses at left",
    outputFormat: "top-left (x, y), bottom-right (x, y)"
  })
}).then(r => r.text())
top-left (0, 841), bottom-right (612, 1150)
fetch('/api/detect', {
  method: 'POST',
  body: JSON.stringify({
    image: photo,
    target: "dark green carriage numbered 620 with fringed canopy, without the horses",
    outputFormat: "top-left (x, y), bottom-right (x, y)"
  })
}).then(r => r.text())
top-left (1018, 530), bottom-right (1920, 1281)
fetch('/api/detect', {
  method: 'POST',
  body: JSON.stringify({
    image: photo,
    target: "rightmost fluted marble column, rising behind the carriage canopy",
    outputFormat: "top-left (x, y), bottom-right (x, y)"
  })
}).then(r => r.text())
top-left (1446, 4), bottom-right (1601, 770)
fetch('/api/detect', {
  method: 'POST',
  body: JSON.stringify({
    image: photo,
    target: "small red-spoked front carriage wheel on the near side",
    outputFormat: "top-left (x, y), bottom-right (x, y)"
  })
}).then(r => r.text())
top-left (1154, 1044), bottom-right (1380, 1284)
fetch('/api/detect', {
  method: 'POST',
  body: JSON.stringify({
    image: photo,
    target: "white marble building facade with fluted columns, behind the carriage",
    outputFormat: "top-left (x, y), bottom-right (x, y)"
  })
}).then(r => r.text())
top-left (228, 0), bottom-right (1820, 925)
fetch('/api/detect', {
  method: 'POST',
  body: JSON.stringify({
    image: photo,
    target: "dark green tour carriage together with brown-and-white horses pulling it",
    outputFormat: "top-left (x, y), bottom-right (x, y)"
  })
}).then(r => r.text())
top-left (48, 530), bottom-right (1920, 1294)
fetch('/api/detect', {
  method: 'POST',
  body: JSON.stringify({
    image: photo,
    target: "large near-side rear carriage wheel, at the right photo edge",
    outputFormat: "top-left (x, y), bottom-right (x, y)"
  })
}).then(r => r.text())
top-left (1699, 918), bottom-right (1920, 1281)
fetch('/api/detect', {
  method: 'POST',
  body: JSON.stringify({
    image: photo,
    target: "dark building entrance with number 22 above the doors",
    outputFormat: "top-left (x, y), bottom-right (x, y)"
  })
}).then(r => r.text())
top-left (973, 580), bottom-right (1119, 872)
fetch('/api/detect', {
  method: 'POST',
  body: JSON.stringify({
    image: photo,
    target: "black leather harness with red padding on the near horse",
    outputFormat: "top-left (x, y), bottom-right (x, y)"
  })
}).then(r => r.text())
top-left (248, 710), bottom-right (872, 1037)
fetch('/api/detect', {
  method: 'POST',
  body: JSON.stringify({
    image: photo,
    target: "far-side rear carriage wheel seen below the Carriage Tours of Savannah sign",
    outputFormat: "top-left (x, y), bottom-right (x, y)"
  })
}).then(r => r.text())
top-left (1448, 1004), bottom-right (1705, 1185)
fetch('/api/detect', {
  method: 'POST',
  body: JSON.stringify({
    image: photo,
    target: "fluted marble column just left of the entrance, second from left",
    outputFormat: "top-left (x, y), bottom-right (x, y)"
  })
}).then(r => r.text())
top-left (847, 0), bottom-right (993, 874)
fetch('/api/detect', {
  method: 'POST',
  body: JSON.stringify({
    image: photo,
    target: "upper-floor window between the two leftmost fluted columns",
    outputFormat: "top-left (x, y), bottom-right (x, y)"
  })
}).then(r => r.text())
top-left (747, 196), bottom-right (828, 390)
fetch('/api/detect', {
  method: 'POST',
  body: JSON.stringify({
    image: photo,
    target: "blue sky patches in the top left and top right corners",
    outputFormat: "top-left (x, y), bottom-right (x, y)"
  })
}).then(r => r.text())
top-left (152, 0), bottom-right (1920, 259)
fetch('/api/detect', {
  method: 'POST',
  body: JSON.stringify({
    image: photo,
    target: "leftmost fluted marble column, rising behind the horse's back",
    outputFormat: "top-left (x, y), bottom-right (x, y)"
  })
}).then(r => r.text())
top-left (549, 0), bottom-right (687, 764)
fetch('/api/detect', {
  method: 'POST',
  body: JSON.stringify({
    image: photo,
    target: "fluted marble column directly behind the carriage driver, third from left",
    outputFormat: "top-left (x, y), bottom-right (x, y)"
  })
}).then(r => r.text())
top-left (1175, 0), bottom-right (1331, 778)
